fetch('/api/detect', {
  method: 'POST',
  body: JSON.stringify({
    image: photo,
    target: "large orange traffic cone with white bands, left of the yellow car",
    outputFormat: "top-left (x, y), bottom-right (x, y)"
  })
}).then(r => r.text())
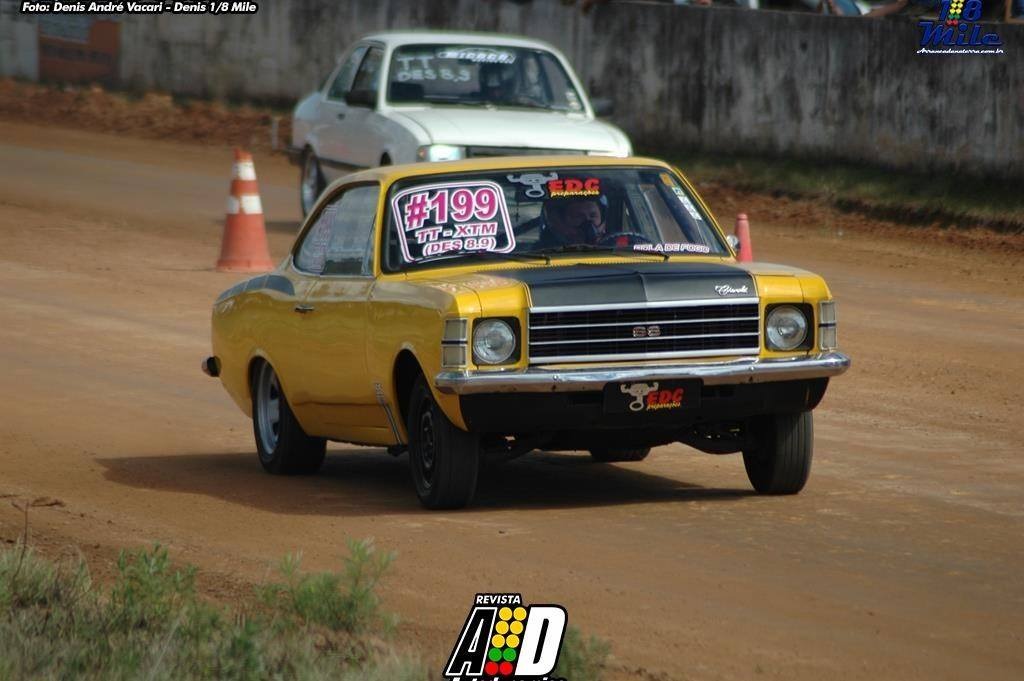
top-left (217, 148), bottom-right (273, 272)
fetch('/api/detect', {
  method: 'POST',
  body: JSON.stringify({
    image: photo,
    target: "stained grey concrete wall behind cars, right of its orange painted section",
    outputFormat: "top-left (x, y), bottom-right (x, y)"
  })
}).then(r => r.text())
top-left (0, 0), bottom-right (1024, 178)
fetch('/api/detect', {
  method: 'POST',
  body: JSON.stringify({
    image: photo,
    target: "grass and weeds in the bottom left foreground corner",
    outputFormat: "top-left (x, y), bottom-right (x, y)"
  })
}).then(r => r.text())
top-left (0, 542), bottom-right (429, 681)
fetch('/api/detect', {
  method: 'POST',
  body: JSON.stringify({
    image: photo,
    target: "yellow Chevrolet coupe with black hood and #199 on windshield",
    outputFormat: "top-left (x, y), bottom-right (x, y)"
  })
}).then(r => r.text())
top-left (203, 156), bottom-right (850, 508)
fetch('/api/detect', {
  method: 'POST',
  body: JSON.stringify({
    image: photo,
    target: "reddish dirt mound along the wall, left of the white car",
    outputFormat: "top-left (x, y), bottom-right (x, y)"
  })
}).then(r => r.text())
top-left (0, 79), bottom-right (291, 151)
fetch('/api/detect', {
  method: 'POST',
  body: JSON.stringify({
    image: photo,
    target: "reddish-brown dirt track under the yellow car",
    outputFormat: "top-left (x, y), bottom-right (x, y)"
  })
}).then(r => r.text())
top-left (0, 123), bottom-right (1024, 681)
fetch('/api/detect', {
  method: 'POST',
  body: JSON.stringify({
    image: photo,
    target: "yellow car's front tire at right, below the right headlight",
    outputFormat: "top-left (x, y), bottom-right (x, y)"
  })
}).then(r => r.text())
top-left (743, 412), bottom-right (814, 495)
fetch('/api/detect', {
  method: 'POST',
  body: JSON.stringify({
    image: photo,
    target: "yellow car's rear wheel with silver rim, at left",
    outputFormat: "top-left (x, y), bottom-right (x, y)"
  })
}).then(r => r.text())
top-left (252, 361), bottom-right (327, 475)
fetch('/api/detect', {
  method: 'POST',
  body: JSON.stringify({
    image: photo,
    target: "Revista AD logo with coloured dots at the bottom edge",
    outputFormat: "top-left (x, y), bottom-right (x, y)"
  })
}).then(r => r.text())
top-left (444, 594), bottom-right (568, 681)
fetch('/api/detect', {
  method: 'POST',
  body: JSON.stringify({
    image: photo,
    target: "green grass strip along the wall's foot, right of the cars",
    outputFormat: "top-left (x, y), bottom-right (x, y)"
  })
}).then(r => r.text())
top-left (674, 153), bottom-right (1024, 233)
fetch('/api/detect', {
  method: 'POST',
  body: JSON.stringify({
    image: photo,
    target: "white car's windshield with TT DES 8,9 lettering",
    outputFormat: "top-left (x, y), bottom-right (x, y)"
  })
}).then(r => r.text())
top-left (387, 44), bottom-right (583, 112)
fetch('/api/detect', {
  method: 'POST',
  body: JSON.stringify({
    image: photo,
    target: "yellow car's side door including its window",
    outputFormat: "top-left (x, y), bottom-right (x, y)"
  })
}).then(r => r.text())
top-left (298, 183), bottom-right (393, 444)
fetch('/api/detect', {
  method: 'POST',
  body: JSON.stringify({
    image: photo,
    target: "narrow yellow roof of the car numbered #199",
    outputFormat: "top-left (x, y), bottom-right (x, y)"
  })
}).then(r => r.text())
top-left (332, 155), bottom-right (671, 191)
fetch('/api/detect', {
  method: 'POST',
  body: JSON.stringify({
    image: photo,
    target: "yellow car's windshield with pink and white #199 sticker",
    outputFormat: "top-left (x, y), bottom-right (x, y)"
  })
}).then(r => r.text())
top-left (385, 166), bottom-right (728, 271)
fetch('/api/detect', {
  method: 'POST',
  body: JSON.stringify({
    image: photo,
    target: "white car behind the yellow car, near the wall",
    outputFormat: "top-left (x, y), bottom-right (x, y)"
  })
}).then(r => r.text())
top-left (289, 32), bottom-right (633, 214)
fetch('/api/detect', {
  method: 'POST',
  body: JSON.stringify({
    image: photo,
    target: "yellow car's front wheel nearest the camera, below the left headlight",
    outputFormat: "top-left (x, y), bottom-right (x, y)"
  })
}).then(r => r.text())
top-left (406, 376), bottom-right (480, 509)
